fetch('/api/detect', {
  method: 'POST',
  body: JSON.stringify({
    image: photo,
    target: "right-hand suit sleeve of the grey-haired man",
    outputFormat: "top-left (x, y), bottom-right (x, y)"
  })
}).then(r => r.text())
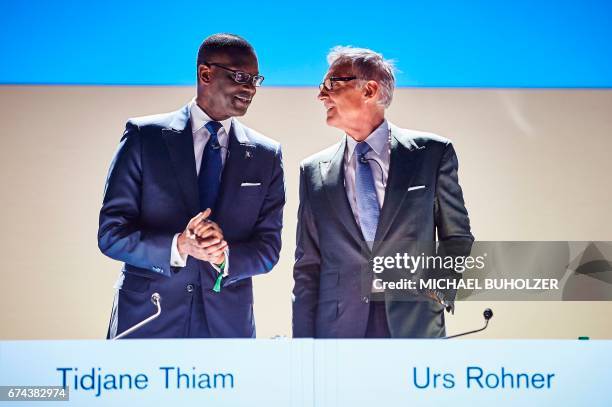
top-left (434, 142), bottom-right (474, 310)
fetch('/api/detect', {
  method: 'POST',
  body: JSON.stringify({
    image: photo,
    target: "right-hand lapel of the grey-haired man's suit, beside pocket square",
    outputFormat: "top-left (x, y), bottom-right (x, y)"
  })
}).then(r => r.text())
top-left (375, 123), bottom-right (423, 246)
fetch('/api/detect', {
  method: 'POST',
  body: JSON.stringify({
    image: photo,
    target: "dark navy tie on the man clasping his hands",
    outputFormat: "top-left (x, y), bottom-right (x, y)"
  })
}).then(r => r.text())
top-left (198, 121), bottom-right (223, 211)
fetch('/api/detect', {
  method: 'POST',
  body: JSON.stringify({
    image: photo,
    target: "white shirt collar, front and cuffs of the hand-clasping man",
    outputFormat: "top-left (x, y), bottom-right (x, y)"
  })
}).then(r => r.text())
top-left (170, 99), bottom-right (232, 276)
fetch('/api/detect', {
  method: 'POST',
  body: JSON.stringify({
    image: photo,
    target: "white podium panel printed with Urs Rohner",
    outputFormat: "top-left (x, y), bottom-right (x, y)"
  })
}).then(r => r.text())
top-left (314, 340), bottom-right (612, 407)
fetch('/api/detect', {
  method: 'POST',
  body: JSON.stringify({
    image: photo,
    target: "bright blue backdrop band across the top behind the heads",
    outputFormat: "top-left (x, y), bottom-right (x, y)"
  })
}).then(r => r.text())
top-left (0, 0), bottom-right (612, 88)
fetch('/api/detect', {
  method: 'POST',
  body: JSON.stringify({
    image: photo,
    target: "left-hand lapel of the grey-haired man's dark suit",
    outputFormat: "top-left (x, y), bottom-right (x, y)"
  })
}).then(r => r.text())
top-left (319, 138), bottom-right (367, 247)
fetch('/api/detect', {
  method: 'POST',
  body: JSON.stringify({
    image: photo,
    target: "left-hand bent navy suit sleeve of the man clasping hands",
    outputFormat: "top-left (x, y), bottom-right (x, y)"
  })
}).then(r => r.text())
top-left (98, 122), bottom-right (174, 277)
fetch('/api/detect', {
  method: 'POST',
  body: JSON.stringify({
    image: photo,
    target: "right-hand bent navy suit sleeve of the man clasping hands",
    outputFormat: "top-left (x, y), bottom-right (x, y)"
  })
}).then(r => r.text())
top-left (223, 147), bottom-right (285, 286)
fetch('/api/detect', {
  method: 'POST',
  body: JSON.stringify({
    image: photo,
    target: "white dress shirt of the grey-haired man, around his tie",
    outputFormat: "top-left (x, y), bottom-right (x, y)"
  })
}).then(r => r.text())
top-left (344, 120), bottom-right (391, 225)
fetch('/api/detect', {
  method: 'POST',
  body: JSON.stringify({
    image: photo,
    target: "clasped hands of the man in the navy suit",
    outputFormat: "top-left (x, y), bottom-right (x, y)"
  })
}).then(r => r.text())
top-left (177, 209), bottom-right (227, 264)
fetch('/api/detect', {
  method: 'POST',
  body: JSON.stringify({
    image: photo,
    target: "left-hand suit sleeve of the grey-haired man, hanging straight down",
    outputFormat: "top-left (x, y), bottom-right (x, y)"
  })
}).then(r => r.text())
top-left (293, 163), bottom-right (321, 338)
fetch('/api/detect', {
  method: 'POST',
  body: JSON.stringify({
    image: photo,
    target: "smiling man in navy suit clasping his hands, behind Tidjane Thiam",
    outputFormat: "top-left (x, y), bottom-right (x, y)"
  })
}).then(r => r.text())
top-left (98, 34), bottom-right (285, 338)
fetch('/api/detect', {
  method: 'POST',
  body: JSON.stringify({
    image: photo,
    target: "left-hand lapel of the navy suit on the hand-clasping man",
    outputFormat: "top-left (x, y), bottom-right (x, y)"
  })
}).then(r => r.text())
top-left (162, 105), bottom-right (199, 216)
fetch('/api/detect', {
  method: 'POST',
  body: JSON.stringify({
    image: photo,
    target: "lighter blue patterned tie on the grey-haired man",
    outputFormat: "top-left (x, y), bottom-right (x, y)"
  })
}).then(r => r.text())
top-left (355, 141), bottom-right (380, 247)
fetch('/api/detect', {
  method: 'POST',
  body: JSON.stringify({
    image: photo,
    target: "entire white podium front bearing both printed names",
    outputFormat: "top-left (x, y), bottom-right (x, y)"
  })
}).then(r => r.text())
top-left (0, 339), bottom-right (612, 407)
